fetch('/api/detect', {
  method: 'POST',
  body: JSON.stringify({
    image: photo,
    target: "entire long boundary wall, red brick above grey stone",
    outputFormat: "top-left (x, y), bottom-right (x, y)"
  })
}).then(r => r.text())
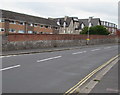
top-left (2, 34), bottom-right (120, 51)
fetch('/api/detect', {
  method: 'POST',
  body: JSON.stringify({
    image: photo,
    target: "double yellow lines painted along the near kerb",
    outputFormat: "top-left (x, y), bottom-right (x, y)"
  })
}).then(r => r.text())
top-left (64, 54), bottom-right (120, 95)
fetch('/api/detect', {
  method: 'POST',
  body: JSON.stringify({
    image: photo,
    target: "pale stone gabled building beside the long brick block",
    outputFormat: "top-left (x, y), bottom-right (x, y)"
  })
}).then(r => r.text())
top-left (54, 16), bottom-right (80, 34)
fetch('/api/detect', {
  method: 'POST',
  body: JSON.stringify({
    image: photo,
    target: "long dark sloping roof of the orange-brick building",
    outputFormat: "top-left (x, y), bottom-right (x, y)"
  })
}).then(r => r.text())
top-left (0, 9), bottom-right (58, 26)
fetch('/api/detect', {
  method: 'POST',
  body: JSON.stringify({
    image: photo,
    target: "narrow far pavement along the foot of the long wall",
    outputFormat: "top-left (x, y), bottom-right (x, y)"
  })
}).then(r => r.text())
top-left (0, 44), bottom-right (117, 56)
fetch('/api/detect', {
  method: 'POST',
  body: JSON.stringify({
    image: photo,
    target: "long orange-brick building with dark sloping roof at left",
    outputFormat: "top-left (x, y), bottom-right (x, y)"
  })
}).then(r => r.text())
top-left (0, 10), bottom-right (59, 34)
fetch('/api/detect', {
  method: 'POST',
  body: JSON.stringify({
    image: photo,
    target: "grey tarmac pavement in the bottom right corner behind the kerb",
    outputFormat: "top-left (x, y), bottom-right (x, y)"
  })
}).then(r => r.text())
top-left (90, 63), bottom-right (120, 93)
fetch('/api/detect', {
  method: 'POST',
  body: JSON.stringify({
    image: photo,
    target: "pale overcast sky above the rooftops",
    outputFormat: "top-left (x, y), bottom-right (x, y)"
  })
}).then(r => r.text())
top-left (0, 0), bottom-right (119, 24)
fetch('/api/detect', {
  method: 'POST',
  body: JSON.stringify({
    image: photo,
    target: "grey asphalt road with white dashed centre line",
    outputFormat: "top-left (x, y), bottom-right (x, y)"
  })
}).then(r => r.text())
top-left (0, 45), bottom-right (118, 93)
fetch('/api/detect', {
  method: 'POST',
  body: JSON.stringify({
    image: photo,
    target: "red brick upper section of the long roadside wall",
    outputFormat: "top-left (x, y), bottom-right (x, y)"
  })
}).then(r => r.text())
top-left (8, 34), bottom-right (116, 42)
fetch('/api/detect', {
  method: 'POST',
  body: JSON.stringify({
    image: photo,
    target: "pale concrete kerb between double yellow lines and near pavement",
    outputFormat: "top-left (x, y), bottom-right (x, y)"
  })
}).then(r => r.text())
top-left (77, 56), bottom-right (120, 93)
